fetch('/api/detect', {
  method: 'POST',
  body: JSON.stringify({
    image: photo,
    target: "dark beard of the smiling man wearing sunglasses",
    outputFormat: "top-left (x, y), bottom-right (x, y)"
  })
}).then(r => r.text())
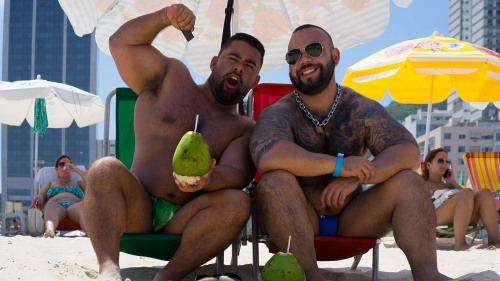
top-left (288, 56), bottom-right (335, 96)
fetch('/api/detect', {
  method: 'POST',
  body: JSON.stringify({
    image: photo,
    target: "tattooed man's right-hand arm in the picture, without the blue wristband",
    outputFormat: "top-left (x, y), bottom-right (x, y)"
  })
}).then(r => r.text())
top-left (354, 96), bottom-right (420, 183)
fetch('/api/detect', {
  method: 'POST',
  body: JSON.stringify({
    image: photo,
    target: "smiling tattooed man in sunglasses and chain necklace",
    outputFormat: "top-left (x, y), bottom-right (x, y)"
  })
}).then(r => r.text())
top-left (250, 25), bottom-right (449, 281)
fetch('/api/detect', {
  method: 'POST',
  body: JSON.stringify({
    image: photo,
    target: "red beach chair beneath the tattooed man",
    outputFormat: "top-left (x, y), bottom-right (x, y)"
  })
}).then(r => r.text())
top-left (248, 83), bottom-right (380, 280)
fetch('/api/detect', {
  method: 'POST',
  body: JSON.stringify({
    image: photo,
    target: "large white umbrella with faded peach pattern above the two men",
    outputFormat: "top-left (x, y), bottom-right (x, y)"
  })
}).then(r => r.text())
top-left (59, 0), bottom-right (412, 77)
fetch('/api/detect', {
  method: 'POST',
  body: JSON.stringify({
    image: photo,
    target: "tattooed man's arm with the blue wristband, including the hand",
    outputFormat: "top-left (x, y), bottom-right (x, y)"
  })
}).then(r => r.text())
top-left (250, 96), bottom-right (374, 178)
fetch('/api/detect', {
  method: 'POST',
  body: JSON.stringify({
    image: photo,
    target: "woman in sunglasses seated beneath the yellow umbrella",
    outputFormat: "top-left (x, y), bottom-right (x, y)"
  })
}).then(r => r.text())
top-left (422, 148), bottom-right (500, 251)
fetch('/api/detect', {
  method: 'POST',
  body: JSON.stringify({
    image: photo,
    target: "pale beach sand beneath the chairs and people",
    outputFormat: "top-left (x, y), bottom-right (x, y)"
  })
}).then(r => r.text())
top-left (0, 232), bottom-right (500, 281)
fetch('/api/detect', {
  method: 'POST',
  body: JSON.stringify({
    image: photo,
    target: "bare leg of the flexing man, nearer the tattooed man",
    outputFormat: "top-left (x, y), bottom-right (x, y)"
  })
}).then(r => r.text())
top-left (154, 189), bottom-right (250, 281)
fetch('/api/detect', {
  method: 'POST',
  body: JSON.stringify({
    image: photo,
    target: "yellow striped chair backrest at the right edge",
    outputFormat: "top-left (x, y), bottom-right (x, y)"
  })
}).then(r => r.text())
top-left (464, 152), bottom-right (500, 197)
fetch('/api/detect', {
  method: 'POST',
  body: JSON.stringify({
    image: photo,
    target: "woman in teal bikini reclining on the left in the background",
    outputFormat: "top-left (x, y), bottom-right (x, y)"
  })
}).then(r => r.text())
top-left (35, 155), bottom-right (87, 237)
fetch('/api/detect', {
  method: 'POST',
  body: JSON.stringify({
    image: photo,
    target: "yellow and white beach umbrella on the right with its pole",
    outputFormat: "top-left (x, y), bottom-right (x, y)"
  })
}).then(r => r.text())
top-left (343, 32), bottom-right (500, 153)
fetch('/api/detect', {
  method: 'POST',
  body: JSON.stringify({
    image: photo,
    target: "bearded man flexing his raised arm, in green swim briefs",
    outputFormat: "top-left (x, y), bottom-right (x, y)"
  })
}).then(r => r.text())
top-left (85, 4), bottom-right (264, 281)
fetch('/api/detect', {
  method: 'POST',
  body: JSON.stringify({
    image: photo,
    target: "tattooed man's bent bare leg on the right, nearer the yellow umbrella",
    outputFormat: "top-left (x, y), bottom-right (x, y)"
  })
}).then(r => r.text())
top-left (338, 170), bottom-right (450, 281)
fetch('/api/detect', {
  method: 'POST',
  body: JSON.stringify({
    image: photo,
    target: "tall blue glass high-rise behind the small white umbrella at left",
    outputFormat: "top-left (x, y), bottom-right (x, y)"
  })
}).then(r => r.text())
top-left (1, 0), bottom-right (97, 209)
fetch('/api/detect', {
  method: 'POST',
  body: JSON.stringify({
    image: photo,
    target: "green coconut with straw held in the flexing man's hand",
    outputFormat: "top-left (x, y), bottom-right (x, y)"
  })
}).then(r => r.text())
top-left (172, 131), bottom-right (212, 185)
